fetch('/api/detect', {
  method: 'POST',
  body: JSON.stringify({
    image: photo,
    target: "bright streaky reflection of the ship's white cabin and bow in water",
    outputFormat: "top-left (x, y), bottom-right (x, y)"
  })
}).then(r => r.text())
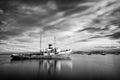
top-left (38, 60), bottom-right (72, 77)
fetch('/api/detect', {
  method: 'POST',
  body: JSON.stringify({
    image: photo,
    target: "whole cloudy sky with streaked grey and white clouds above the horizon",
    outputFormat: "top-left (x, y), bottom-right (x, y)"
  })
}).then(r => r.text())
top-left (0, 0), bottom-right (120, 52)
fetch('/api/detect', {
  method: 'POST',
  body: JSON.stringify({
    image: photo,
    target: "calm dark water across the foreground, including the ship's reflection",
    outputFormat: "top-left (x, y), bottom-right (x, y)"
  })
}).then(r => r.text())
top-left (0, 54), bottom-right (120, 80)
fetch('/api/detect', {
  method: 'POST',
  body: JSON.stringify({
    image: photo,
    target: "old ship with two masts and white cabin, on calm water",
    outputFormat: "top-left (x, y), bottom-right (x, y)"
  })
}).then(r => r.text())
top-left (11, 35), bottom-right (72, 60)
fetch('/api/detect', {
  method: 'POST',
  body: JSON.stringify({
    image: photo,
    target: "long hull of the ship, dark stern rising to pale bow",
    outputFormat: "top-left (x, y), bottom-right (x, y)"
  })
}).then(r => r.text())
top-left (11, 51), bottom-right (71, 60)
